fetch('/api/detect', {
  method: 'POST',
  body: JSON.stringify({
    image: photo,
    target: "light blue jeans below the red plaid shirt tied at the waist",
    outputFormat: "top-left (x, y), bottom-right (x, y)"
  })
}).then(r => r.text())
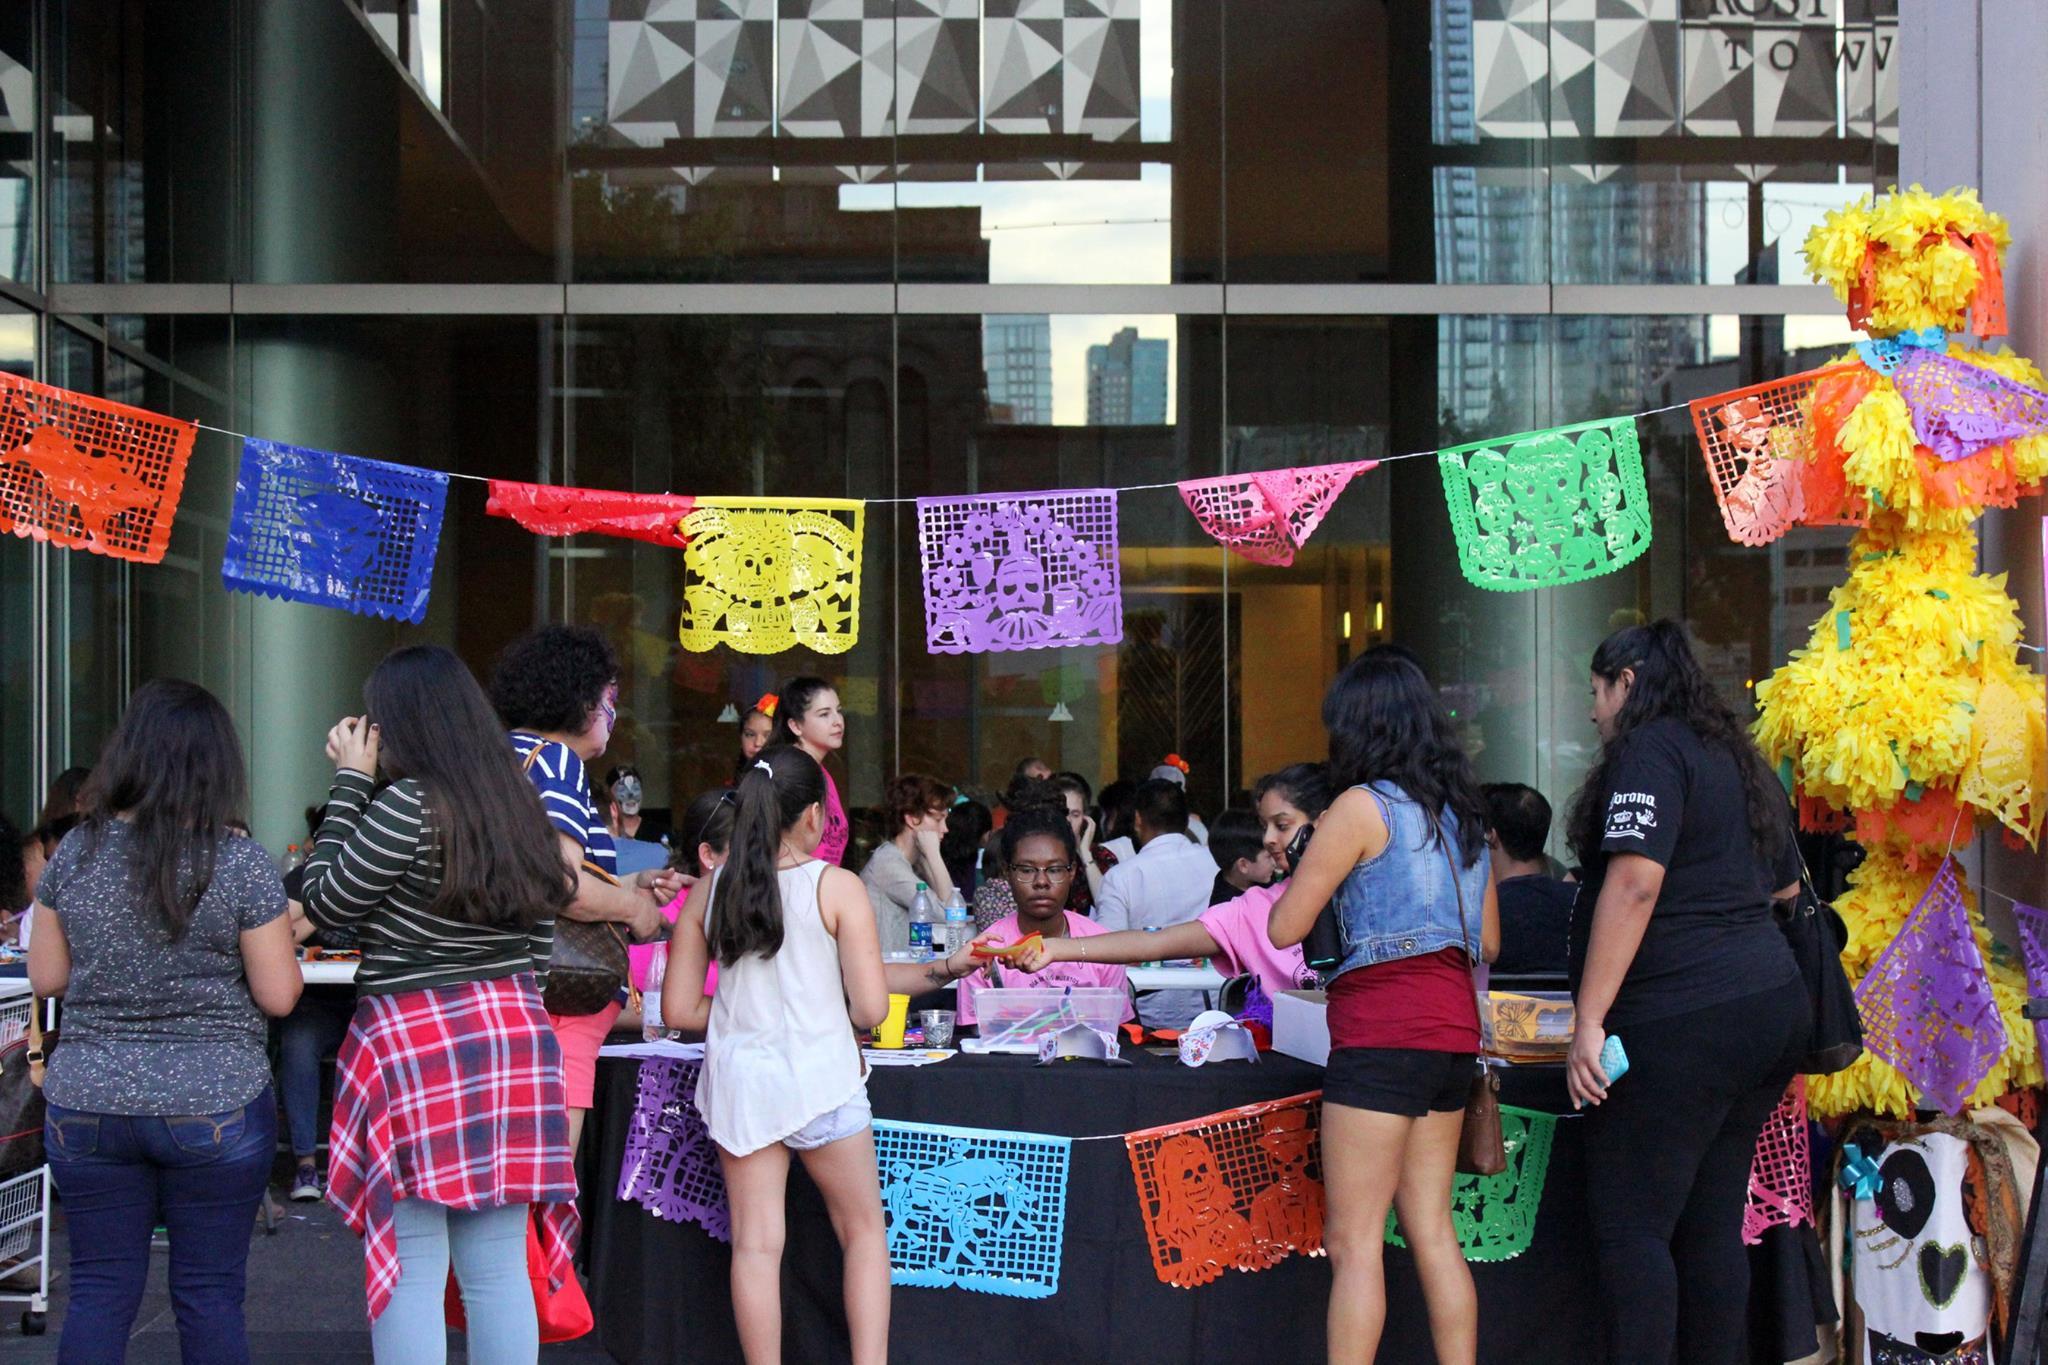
top-left (371, 1199), bottom-right (541, 1365)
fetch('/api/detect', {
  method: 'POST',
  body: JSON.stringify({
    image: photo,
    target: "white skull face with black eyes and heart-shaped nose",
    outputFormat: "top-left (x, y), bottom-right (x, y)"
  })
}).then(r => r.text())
top-left (1849, 1134), bottom-right (1993, 1365)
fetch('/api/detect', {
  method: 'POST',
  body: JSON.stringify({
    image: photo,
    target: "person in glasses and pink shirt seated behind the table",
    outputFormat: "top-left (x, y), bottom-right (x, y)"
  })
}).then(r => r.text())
top-left (958, 806), bottom-right (1138, 1025)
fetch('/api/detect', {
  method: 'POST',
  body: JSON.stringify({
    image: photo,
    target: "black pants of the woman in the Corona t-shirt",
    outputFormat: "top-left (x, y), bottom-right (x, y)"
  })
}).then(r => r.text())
top-left (1585, 978), bottom-right (1812, 1365)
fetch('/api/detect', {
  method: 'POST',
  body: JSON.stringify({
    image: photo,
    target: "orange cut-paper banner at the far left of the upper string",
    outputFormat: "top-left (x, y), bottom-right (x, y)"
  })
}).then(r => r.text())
top-left (0, 372), bottom-right (199, 565)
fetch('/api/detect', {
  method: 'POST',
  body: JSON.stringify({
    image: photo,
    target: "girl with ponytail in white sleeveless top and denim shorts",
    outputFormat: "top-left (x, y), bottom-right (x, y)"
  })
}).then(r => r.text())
top-left (662, 745), bottom-right (889, 1365)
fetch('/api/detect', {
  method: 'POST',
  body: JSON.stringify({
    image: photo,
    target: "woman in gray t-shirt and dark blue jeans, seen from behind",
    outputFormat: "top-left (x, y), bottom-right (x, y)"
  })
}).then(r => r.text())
top-left (29, 681), bottom-right (299, 1361)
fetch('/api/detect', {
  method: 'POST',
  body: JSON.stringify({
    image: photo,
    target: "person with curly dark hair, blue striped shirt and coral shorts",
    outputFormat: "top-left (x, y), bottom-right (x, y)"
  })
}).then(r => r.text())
top-left (492, 626), bottom-right (682, 1152)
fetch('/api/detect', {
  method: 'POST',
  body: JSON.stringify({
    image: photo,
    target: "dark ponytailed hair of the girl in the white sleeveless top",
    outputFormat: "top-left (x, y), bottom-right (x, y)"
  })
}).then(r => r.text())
top-left (705, 745), bottom-right (825, 966)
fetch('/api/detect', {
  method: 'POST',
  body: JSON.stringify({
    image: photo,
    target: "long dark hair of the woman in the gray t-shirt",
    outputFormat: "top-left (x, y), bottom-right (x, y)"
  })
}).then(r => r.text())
top-left (78, 677), bottom-right (248, 941)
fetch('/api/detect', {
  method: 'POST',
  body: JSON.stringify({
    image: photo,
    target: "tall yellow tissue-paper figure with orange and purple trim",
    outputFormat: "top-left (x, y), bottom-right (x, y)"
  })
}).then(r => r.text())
top-left (1755, 186), bottom-right (2048, 1117)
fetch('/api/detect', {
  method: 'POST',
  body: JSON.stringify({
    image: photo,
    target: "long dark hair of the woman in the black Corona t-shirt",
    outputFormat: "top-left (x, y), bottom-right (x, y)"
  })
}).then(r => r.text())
top-left (1567, 618), bottom-right (1786, 864)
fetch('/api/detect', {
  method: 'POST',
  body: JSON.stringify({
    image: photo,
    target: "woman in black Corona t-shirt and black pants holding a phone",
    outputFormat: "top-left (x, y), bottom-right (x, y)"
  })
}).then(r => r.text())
top-left (1567, 620), bottom-right (1810, 1363)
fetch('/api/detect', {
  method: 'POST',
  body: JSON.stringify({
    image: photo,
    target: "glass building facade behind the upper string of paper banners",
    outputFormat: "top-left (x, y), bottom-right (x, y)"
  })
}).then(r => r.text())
top-left (0, 0), bottom-right (1901, 845)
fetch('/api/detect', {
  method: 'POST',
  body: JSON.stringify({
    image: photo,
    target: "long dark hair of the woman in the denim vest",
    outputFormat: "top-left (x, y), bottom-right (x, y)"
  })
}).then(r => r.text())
top-left (1323, 647), bottom-right (1487, 868)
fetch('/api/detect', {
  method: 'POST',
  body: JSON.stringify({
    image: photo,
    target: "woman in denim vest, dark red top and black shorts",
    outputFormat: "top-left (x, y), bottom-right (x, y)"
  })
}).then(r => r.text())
top-left (1268, 647), bottom-right (1501, 1361)
